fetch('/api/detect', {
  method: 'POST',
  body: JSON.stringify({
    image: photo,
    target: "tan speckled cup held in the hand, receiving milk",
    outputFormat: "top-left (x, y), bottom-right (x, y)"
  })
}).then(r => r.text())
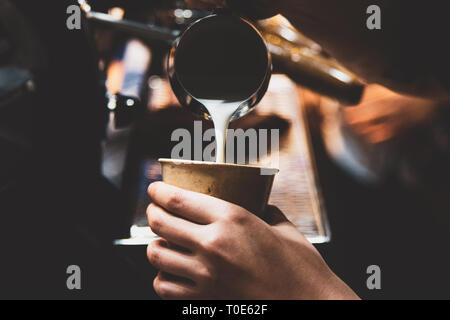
top-left (159, 159), bottom-right (278, 219)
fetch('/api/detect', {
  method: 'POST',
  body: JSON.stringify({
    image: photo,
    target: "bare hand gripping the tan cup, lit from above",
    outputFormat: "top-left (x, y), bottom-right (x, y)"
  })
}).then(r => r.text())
top-left (147, 182), bottom-right (358, 299)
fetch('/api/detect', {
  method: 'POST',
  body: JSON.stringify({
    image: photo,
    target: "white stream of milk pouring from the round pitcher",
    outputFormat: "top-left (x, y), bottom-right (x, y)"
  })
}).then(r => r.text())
top-left (198, 99), bottom-right (242, 163)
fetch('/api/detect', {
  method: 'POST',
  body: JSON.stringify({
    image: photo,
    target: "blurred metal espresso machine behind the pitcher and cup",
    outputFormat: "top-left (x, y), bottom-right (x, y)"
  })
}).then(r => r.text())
top-left (62, 0), bottom-right (370, 245)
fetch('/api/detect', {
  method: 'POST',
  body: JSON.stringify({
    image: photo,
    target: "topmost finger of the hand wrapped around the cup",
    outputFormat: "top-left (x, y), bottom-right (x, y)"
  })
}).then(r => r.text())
top-left (148, 182), bottom-right (233, 224)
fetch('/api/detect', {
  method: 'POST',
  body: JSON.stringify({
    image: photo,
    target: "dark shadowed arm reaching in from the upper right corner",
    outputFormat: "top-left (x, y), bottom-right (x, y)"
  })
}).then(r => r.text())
top-left (186, 0), bottom-right (450, 100)
